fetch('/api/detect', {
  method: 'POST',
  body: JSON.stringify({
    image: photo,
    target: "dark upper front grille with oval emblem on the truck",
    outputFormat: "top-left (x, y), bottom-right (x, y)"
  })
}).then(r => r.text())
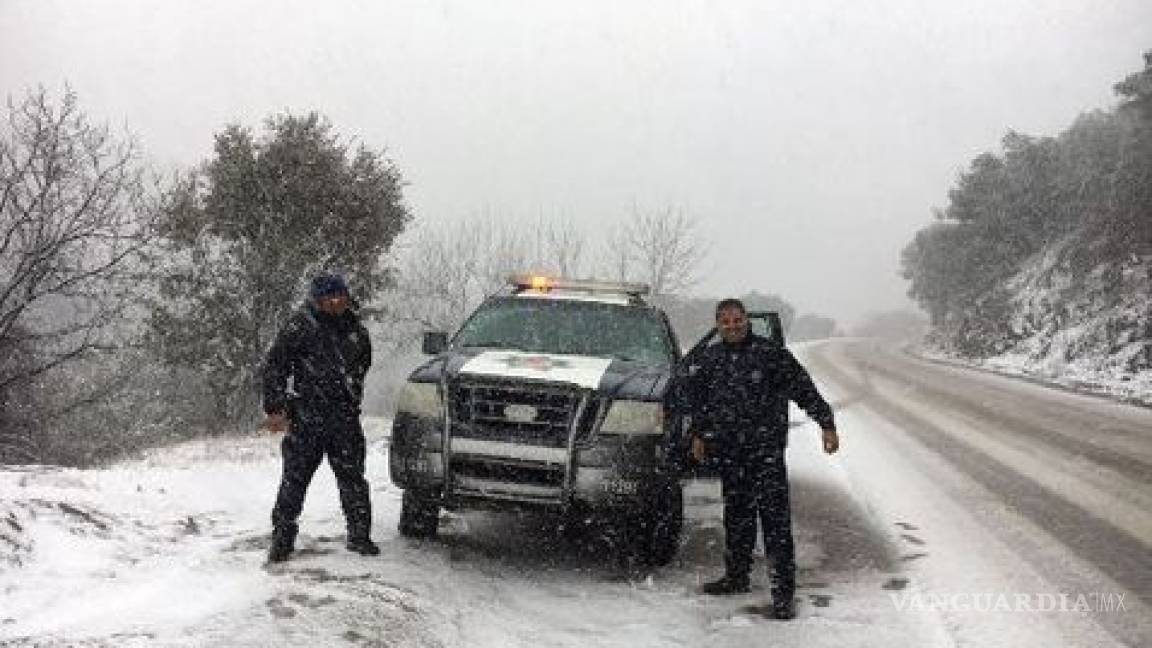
top-left (448, 382), bottom-right (596, 447)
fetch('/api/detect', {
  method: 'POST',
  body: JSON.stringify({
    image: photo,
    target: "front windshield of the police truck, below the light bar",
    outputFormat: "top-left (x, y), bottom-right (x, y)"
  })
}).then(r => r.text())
top-left (453, 297), bottom-right (673, 366)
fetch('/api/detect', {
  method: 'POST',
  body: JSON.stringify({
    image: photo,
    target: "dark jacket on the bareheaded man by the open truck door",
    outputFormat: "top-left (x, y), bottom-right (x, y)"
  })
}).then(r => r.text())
top-left (690, 333), bottom-right (835, 455)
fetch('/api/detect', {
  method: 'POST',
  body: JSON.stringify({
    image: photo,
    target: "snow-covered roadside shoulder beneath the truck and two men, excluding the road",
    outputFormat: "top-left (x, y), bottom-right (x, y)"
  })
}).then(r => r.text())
top-left (0, 412), bottom-right (949, 647)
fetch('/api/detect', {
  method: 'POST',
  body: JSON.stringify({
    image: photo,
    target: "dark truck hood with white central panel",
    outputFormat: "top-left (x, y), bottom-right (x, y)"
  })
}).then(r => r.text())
top-left (410, 348), bottom-right (670, 400)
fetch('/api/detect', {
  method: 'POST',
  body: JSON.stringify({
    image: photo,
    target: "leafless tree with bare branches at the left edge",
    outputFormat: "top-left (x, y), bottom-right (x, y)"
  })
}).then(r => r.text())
top-left (0, 88), bottom-right (152, 460)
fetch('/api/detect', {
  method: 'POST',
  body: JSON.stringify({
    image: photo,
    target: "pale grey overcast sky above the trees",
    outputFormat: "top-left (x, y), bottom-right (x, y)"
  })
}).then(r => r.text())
top-left (0, 0), bottom-right (1152, 324)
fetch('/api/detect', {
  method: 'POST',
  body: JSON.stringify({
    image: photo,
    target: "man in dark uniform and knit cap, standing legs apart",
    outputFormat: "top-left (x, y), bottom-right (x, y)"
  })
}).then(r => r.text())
top-left (264, 273), bottom-right (380, 563)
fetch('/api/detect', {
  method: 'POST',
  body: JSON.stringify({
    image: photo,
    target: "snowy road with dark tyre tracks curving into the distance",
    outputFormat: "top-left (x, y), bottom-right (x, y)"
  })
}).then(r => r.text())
top-left (808, 340), bottom-right (1152, 646)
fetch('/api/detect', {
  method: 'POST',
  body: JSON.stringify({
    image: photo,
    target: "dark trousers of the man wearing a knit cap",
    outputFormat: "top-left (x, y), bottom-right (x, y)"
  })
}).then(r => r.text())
top-left (272, 416), bottom-right (372, 538)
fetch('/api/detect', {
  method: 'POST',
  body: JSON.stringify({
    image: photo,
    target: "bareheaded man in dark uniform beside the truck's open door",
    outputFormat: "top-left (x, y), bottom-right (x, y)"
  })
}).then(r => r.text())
top-left (690, 299), bottom-right (840, 619)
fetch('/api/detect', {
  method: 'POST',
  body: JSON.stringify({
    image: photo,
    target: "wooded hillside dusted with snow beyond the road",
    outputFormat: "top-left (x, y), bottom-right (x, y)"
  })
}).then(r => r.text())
top-left (901, 52), bottom-right (1152, 401)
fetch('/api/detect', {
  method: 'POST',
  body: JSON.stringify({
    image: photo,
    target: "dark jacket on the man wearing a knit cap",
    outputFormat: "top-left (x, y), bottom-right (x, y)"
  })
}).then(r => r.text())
top-left (264, 301), bottom-right (372, 419)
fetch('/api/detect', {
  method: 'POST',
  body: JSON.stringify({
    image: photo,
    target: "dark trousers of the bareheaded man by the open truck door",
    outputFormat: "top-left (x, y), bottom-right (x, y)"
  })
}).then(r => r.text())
top-left (720, 449), bottom-right (796, 601)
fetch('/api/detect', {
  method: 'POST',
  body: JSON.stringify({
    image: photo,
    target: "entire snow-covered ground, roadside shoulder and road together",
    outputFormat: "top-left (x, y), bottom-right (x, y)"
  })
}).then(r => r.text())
top-left (0, 340), bottom-right (1152, 648)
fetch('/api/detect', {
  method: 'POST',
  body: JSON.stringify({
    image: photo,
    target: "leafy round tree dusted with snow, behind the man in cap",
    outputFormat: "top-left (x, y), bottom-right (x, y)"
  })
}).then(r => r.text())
top-left (150, 113), bottom-right (410, 421)
